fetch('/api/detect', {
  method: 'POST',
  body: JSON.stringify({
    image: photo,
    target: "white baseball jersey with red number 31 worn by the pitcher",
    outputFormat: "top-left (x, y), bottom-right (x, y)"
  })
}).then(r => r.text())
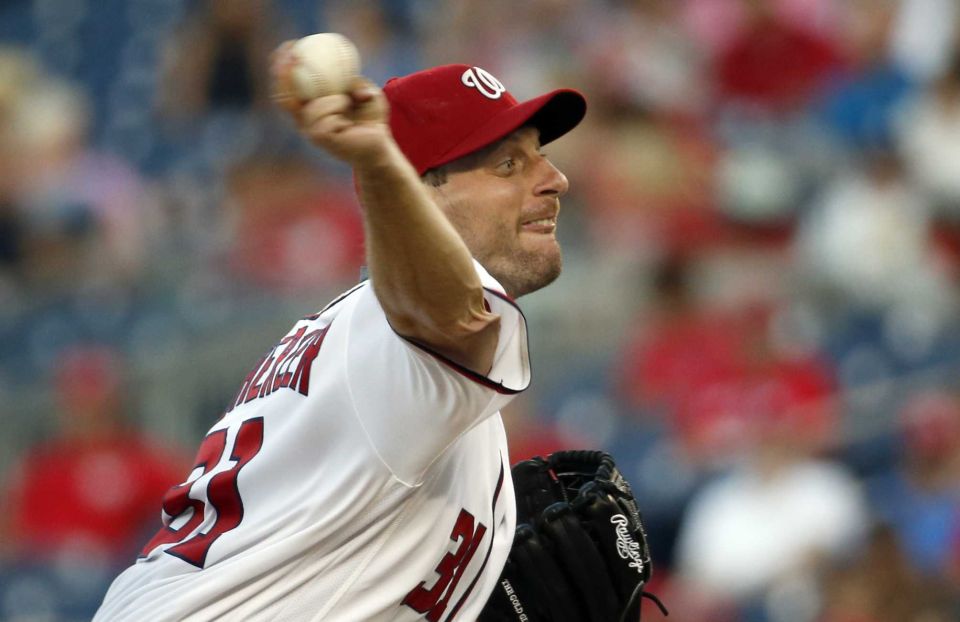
top-left (95, 264), bottom-right (530, 622)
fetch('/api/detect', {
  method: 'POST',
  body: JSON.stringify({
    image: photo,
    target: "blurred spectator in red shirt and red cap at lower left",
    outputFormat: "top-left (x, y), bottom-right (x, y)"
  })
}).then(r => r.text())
top-left (4, 348), bottom-right (185, 563)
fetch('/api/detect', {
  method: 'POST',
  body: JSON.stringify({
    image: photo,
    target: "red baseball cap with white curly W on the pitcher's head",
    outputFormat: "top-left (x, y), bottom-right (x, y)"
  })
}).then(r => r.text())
top-left (383, 65), bottom-right (587, 175)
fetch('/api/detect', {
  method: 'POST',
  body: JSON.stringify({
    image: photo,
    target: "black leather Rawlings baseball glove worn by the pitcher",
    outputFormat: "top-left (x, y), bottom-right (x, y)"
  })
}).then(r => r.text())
top-left (479, 451), bottom-right (659, 622)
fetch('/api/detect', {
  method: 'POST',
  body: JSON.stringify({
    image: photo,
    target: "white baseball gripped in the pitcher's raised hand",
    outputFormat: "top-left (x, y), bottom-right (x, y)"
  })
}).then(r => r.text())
top-left (290, 32), bottom-right (360, 101)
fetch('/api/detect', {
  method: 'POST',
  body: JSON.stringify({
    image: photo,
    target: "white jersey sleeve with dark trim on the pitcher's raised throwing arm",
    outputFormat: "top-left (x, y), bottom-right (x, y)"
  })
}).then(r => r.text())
top-left (338, 262), bottom-right (530, 485)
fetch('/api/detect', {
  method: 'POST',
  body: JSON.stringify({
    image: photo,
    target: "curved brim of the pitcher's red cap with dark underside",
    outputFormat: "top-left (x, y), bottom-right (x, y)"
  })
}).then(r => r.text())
top-left (419, 89), bottom-right (587, 175)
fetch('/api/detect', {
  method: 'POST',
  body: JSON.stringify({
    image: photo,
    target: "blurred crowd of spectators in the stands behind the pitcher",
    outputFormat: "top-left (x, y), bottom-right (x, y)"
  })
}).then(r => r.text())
top-left (0, 0), bottom-right (960, 622)
